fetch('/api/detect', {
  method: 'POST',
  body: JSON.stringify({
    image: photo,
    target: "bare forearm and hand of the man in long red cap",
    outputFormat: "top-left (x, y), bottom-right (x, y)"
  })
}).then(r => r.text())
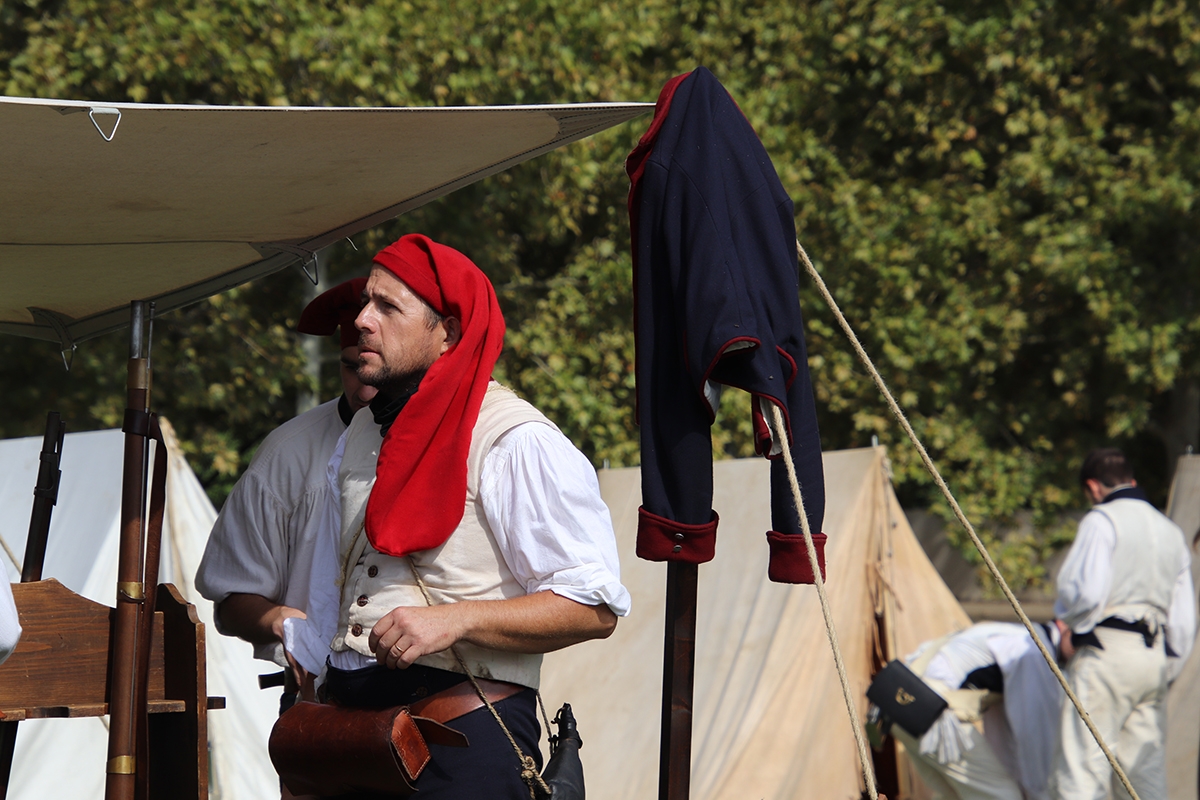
top-left (367, 591), bottom-right (617, 669)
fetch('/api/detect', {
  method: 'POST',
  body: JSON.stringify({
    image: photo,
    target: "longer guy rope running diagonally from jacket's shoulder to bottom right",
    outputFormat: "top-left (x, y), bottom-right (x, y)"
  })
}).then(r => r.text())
top-left (785, 240), bottom-right (1140, 800)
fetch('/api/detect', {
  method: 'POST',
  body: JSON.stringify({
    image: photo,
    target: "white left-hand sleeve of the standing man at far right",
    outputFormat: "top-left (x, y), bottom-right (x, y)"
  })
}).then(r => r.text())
top-left (1054, 511), bottom-right (1117, 633)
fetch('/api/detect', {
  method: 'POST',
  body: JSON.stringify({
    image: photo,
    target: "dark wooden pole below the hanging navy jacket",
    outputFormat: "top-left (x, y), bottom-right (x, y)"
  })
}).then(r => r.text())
top-left (659, 561), bottom-right (698, 800)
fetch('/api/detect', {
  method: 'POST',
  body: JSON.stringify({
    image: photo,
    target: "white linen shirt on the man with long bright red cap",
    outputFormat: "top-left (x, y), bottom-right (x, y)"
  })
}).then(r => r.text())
top-left (284, 422), bottom-right (631, 673)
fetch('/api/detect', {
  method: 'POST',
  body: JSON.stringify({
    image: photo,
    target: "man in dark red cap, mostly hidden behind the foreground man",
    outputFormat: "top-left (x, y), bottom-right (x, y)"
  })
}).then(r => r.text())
top-left (196, 278), bottom-right (376, 705)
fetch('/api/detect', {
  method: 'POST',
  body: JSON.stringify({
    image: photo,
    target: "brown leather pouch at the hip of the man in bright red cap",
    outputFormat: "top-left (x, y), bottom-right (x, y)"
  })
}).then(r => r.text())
top-left (268, 680), bottom-right (524, 798)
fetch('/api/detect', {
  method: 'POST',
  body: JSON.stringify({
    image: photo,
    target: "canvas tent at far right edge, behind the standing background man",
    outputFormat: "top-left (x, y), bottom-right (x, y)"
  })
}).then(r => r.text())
top-left (1166, 456), bottom-right (1200, 800)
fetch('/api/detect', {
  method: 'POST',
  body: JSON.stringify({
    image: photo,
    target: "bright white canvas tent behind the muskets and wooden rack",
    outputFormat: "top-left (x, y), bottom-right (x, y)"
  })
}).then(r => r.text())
top-left (0, 426), bottom-right (280, 800)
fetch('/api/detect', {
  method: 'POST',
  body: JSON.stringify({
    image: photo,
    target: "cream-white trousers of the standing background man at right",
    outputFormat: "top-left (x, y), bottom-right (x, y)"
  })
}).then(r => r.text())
top-left (1050, 627), bottom-right (1166, 800)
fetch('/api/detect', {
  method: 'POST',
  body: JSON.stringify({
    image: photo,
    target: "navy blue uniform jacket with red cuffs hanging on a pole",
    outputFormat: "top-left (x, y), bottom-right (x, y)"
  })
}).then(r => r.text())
top-left (625, 67), bottom-right (824, 583)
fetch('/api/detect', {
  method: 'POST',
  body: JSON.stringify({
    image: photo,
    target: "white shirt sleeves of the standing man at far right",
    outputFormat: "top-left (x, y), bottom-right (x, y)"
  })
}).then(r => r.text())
top-left (1054, 511), bottom-right (1196, 680)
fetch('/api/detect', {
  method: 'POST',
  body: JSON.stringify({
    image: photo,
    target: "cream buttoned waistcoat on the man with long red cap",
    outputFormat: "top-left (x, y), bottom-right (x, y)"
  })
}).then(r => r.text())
top-left (331, 383), bottom-right (553, 688)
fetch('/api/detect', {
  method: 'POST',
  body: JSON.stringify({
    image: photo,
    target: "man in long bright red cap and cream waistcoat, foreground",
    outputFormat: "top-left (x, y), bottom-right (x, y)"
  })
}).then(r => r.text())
top-left (310, 234), bottom-right (629, 800)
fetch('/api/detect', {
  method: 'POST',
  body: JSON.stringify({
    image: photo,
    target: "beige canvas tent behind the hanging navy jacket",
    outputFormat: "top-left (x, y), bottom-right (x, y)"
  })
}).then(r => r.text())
top-left (542, 447), bottom-right (970, 800)
